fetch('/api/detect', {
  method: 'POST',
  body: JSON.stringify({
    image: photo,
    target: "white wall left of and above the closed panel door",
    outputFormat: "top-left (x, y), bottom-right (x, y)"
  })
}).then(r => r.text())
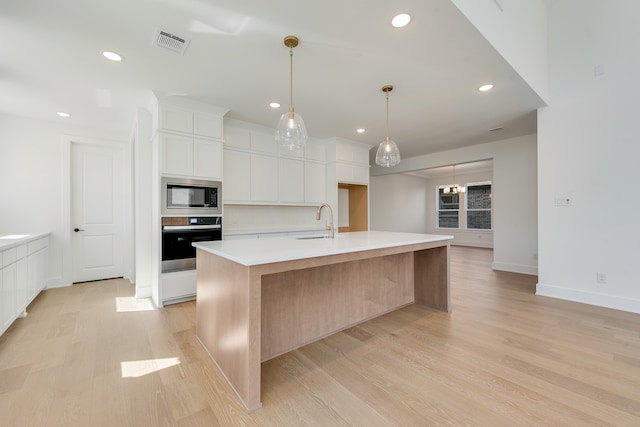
top-left (0, 114), bottom-right (128, 286)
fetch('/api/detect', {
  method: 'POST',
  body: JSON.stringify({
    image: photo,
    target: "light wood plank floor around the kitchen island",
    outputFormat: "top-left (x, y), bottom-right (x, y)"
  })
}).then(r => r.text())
top-left (0, 247), bottom-right (640, 426)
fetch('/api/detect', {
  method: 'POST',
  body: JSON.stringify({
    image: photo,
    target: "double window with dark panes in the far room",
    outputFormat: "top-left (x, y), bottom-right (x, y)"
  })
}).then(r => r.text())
top-left (437, 181), bottom-right (492, 230)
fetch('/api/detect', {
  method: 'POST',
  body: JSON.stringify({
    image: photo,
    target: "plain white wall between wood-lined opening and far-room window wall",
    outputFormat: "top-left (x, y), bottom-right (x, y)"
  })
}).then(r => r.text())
top-left (369, 174), bottom-right (429, 233)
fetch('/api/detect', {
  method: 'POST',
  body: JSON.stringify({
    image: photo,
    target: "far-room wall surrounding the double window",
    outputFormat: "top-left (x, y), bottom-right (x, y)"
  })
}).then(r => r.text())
top-left (426, 170), bottom-right (495, 248)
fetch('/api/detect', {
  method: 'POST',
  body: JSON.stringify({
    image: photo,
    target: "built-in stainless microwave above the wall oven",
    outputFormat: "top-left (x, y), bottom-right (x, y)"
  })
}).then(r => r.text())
top-left (161, 177), bottom-right (222, 215)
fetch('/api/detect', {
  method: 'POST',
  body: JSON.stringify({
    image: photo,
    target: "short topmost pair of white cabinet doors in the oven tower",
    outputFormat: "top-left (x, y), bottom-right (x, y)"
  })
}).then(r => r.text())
top-left (160, 104), bottom-right (222, 140)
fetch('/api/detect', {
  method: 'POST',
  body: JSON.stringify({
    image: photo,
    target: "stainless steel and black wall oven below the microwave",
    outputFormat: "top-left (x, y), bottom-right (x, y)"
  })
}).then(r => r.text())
top-left (162, 216), bottom-right (222, 273)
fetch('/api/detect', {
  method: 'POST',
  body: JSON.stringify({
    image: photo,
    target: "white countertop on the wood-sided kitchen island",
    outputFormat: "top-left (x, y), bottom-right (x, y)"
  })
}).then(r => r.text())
top-left (193, 231), bottom-right (453, 266)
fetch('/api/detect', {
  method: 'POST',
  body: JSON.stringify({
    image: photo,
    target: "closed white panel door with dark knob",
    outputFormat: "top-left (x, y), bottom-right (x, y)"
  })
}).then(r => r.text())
top-left (71, 144), bottom-right (124, 283)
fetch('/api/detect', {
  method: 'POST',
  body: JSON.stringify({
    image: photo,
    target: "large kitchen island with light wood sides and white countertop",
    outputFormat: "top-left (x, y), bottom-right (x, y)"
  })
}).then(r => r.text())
top-left (193, 231), bottom-right (452, 411)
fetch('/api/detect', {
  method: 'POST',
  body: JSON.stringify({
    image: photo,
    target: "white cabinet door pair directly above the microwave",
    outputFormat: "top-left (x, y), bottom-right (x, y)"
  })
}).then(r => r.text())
top-left (160, 133), bottom-right (222, 180)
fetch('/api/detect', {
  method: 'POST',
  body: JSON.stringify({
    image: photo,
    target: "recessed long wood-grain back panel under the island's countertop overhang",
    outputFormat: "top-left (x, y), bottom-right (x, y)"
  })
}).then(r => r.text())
top-left (262, 253), bottom-right (414, 361)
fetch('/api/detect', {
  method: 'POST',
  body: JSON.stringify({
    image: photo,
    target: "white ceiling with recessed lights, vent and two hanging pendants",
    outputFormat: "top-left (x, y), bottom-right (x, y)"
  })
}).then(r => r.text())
top-left (0, 0), bottom-right (543, 158)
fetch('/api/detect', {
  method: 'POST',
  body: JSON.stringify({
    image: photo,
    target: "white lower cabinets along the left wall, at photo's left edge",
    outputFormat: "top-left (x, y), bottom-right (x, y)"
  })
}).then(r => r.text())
top-left (0, 237), bottom-right (49, 335)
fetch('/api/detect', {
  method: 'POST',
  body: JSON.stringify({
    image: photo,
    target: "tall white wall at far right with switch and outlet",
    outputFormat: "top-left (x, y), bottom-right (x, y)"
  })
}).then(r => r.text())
top-left (537, 0), bottom-right (640, 313)
